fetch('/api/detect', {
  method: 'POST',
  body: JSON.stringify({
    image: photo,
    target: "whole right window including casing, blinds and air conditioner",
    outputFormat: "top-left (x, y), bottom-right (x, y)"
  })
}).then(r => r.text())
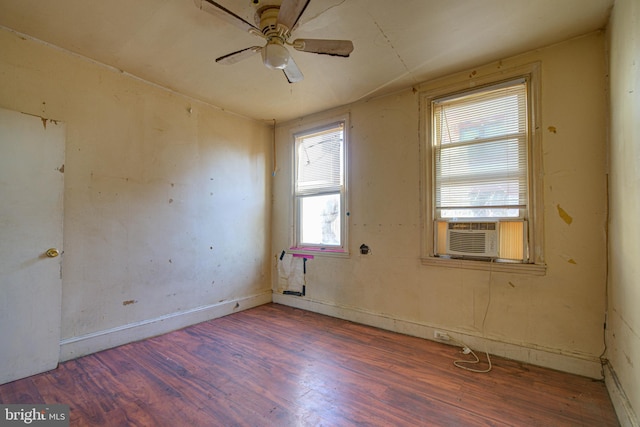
top-left (422, 67), bottom-right (542, 268)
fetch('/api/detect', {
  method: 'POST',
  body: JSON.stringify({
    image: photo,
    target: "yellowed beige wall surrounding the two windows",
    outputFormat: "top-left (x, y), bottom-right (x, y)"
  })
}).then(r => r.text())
top-left (272, 33), bottom-right (607, 377)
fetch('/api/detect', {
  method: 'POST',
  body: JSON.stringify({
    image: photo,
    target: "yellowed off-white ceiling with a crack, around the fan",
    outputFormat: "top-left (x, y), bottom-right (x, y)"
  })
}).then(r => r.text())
top-left (0, 0), bottom-right (614, 121)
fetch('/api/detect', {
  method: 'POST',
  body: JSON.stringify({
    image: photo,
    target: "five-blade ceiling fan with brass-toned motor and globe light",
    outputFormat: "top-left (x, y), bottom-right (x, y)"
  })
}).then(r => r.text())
top-left (194, 0), bottom-right (353, 83)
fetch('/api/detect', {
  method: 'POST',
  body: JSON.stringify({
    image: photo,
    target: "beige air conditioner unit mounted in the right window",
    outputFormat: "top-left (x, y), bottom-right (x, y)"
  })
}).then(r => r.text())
top-left (447, 222), bottom-right (499, 257)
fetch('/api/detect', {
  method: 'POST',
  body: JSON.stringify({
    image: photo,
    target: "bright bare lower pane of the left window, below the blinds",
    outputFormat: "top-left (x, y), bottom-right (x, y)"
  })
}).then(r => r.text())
top-left (299, 193), bottom-right (342, 246)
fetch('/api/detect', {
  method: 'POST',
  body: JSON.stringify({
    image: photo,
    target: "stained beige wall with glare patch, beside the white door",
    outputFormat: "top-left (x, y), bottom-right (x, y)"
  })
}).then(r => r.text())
top-left (0, 31), bottom-right (272, 358)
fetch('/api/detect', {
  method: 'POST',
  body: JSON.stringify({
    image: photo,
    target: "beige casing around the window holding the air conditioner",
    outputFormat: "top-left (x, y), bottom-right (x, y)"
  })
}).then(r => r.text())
top-left (419, 63), bottom-right (546, 275)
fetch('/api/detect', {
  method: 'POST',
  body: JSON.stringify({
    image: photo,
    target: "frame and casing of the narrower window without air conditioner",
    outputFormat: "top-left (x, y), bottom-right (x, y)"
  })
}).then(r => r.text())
top-left (290, 114), bottom-right (350, 256)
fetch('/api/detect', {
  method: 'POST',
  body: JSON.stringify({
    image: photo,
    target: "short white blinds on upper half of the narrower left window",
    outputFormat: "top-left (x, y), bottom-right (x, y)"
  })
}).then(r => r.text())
top-left (296, 123), bottom-right (344, 195)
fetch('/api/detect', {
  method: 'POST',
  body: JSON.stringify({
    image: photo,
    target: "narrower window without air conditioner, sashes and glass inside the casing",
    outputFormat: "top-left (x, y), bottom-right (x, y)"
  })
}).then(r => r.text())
top-left (294, 120), bottom-right (348, 252)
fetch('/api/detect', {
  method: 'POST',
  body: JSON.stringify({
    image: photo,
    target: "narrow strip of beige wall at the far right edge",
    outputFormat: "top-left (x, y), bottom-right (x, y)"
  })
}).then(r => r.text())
top-left (607, 0), bottom-right (640, 425)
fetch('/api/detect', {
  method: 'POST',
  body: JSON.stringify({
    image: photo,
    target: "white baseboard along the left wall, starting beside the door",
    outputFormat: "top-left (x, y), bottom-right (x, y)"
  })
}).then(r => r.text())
top-left (60, 289), bottom-right (272, 362)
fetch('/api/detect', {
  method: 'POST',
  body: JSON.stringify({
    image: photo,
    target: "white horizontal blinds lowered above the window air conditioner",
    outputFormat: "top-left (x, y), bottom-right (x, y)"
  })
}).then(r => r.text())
top-left (432, 79), bottom-right (528, 218)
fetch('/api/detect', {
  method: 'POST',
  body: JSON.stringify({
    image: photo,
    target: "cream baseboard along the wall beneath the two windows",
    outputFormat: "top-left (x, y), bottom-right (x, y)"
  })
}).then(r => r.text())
top-left (273, 292), bottom-right (602, 379)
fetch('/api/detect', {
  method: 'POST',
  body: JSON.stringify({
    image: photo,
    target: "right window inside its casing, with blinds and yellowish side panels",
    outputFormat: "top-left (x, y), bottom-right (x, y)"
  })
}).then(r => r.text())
top-left (430, 79), bottom-right (530, 261)
